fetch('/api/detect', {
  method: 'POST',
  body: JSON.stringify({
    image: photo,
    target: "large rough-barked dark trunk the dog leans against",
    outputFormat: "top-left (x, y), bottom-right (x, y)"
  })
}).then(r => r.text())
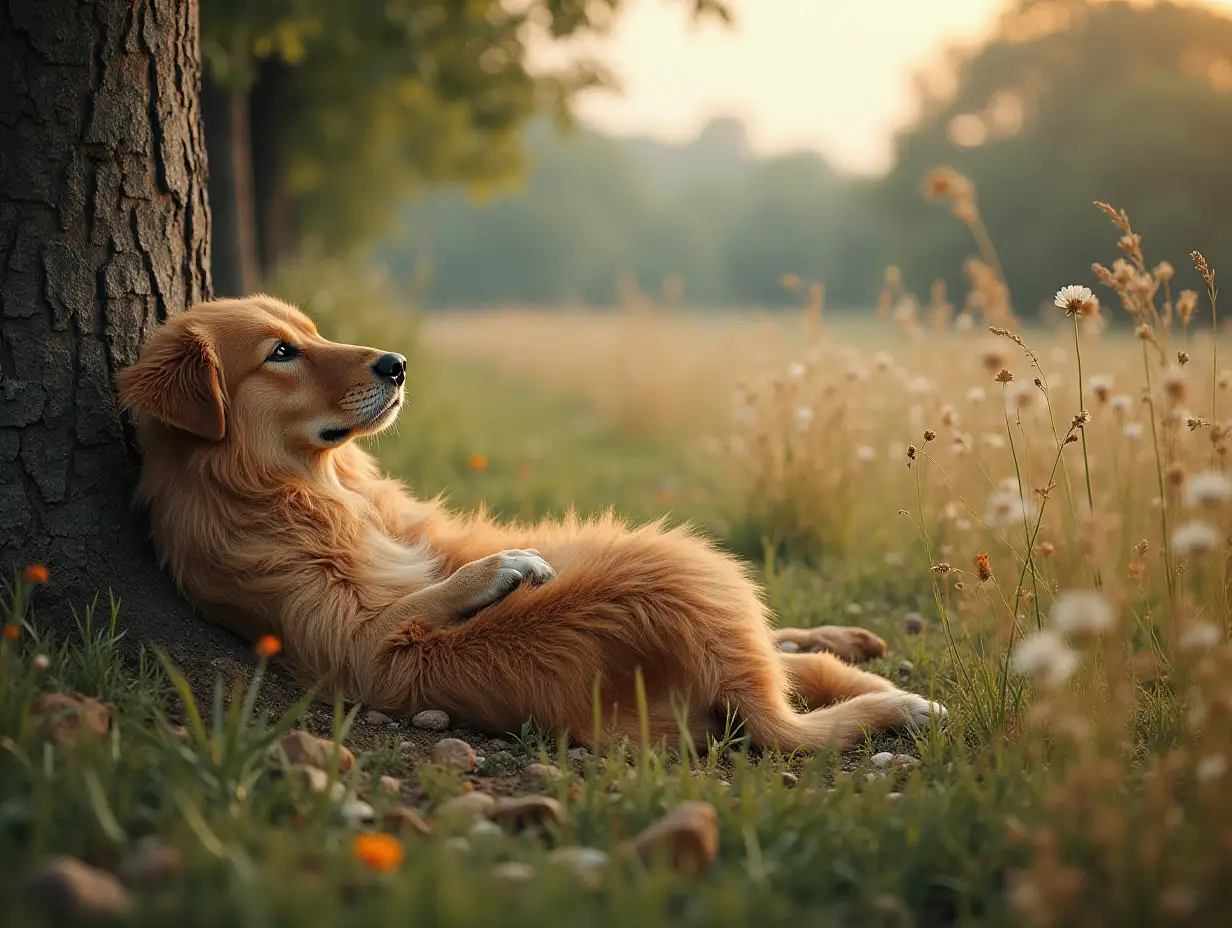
top-left (0, 0), bottom-right (295, 700)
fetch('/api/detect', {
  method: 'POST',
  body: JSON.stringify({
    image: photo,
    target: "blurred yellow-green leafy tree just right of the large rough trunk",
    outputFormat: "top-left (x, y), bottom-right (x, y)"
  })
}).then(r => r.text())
top-left (201, 0), bottom-right (728, 295)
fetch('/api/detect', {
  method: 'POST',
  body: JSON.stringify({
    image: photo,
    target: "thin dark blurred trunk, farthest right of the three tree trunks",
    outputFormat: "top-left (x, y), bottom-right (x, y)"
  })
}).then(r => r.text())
top-left (251, 59), bottom-right (294, 280)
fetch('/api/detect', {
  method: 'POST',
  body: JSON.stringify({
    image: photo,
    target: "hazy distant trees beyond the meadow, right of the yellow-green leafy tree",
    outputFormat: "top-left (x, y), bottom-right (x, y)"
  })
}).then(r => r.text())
top-left (381, 0), bottom-right (1232, 318)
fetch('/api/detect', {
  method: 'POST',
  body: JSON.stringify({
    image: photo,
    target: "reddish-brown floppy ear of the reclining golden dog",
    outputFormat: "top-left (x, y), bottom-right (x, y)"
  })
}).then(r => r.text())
top-left (117, 322), bottom-right (227, 441)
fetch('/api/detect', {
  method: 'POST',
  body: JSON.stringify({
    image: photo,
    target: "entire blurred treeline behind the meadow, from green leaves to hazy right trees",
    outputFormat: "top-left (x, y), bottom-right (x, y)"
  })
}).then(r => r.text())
top-left (202, 0), bottom-right (1232, 315)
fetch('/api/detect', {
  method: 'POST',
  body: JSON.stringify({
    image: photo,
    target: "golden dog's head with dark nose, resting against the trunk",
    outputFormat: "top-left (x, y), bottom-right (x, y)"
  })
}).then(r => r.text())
top-left (118, 296), bottom-right (407, 455)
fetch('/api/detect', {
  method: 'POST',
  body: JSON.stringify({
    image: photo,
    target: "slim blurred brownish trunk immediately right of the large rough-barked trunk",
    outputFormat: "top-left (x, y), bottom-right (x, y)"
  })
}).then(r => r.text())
top-left (201, 78), bottom-right (260, 297)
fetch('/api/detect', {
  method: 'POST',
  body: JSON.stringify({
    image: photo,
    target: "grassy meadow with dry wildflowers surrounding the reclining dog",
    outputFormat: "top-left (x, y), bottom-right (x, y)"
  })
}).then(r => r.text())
top-left (0, 192), bottom-right (1232, 928)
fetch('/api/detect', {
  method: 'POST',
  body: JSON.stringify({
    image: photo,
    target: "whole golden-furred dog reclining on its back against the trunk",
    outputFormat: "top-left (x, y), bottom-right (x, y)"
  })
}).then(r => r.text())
top-left (120, 296), bottom-right (945, 751)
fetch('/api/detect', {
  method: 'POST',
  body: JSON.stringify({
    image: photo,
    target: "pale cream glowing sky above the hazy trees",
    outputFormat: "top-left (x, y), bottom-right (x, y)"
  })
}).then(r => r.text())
top-left (539, 0), bottom-right (1232, 174)
